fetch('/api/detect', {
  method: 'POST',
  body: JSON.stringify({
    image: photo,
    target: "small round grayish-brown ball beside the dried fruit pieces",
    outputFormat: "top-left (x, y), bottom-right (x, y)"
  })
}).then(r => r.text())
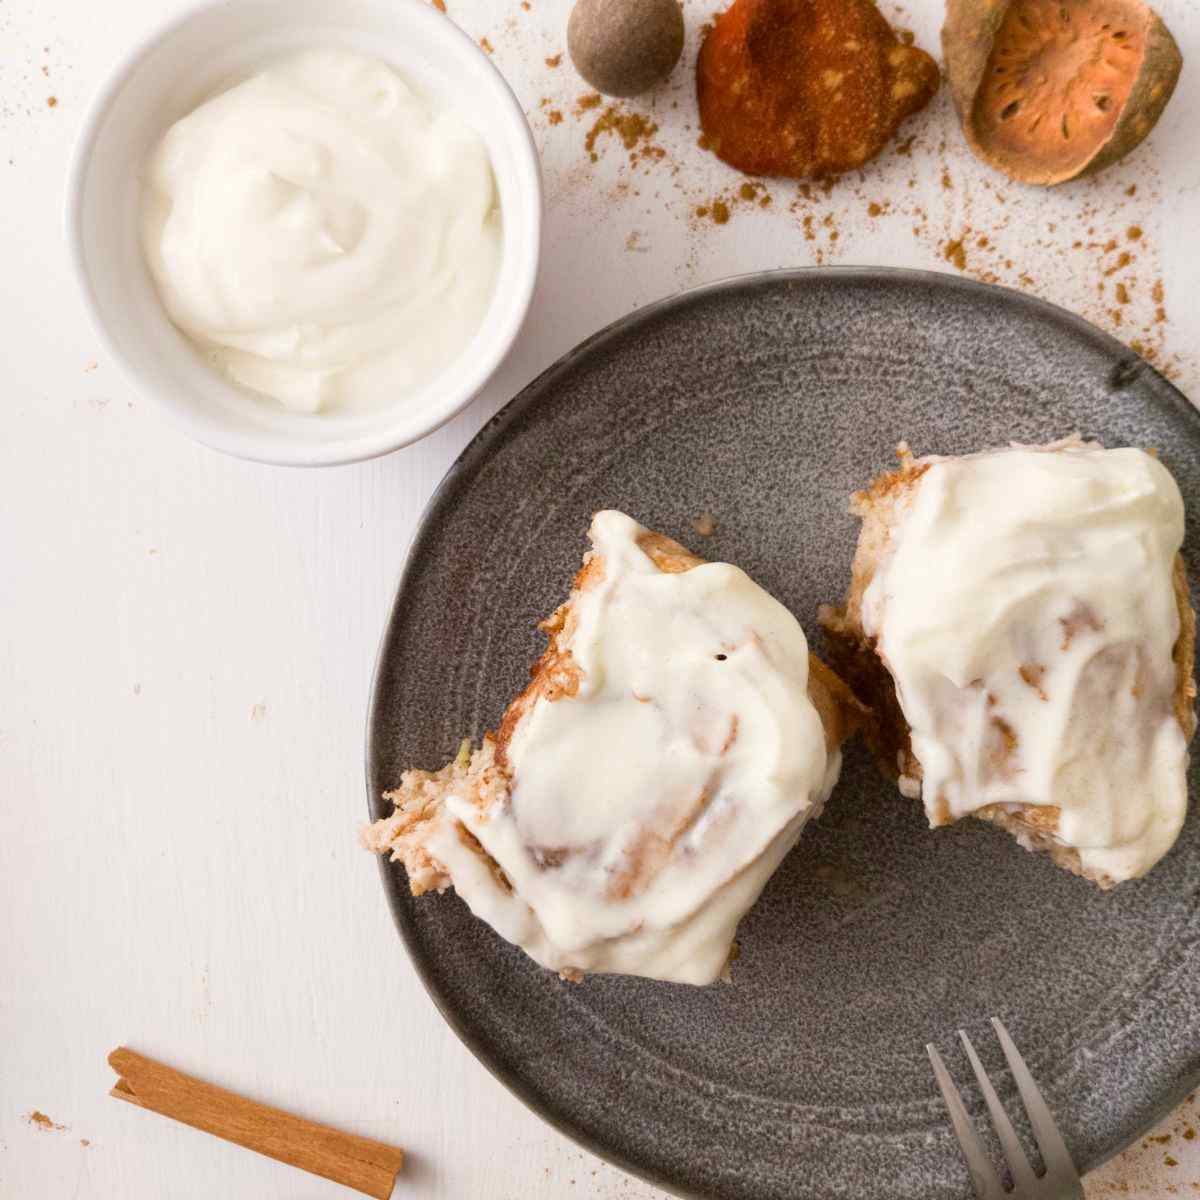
top-left (566, 0), bottom-right (683, 96)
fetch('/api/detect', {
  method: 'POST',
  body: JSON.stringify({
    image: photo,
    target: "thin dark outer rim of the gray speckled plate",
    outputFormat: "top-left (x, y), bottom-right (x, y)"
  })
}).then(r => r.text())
top-left (364, 265), bottom-right (1200, 1200)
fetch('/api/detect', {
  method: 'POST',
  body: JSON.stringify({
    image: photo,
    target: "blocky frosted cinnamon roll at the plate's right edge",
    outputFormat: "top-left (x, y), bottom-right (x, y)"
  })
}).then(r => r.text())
top-left (821, 438), bottom-right (1195, 887)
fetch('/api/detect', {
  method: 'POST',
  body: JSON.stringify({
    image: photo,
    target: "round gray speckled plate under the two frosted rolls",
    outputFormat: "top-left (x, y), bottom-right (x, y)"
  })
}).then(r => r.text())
top-left (368, 269), bottom-right (1200, 1200)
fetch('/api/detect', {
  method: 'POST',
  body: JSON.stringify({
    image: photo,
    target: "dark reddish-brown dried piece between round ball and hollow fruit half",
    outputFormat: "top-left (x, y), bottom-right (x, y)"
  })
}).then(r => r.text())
top-left (696, 0), bottom-right (940, 179)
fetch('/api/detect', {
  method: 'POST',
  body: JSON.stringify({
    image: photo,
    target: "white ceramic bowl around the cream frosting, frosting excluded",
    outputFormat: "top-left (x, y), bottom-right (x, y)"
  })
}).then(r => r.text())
top-left (67, 0), bottom-right (541, 466)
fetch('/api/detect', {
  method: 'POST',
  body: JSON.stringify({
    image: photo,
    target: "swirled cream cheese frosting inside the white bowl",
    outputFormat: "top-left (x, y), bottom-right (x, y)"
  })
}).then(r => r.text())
top-left (142, 48), bottom-right (503, 413)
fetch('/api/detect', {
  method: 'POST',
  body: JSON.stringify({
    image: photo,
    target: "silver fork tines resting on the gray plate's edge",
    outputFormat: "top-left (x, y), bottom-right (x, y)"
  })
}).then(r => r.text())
top-left (925, 1016), bottom-right (1084, 1200)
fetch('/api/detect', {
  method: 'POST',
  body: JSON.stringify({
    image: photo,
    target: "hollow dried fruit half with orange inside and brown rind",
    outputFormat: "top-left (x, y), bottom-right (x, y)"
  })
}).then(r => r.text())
top-left (942, 0), bottom-right (1183, 184)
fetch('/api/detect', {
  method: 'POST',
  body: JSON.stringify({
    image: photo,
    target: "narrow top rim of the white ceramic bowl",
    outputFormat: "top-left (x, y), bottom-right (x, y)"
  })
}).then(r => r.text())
top-left (62, 0), bottom-right (545, 467)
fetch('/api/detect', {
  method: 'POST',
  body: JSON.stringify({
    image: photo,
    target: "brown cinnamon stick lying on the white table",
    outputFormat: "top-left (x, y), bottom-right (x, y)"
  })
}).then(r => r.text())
top-left (108, 1046), bottom-right (404, 1200)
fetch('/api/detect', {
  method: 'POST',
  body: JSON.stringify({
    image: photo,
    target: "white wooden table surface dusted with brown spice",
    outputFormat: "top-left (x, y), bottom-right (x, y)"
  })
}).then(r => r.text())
top-left (0, 0), bottom-right (1200, 1200)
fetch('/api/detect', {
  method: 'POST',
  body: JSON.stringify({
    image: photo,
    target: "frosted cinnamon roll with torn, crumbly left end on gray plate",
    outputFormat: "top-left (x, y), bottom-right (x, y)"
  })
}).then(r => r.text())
top-left (364, 511), bottom-right (857, 984)
